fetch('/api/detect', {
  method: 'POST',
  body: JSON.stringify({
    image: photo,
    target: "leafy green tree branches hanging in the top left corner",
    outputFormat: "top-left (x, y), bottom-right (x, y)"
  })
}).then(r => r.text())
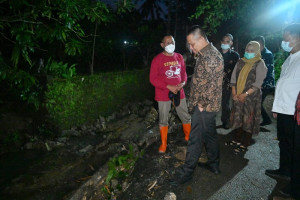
top-left (0, 0), bottom-right (112, 66)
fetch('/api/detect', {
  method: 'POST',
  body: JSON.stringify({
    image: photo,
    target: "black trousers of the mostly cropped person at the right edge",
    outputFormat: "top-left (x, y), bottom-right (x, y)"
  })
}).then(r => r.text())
top-left (291, 122), bottom-right (300, 198)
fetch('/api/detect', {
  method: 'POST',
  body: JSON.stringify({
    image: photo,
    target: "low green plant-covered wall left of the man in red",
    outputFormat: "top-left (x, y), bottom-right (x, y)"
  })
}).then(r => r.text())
top-left (45, 70), bottom-right (153, 130)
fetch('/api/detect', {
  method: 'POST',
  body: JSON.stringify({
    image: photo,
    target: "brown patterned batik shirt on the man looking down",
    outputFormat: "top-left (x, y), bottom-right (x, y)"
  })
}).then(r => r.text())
top-left (189, 43), bottom-right (224, 112)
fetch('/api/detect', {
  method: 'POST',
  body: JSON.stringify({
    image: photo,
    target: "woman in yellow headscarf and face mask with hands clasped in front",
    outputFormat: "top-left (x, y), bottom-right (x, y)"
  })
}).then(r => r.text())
top-left (230, 41), bottom-right (267, 152)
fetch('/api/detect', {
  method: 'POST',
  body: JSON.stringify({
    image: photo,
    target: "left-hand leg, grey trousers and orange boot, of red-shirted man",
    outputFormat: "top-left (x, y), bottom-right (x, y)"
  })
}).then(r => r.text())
top-left (158, 101), bottom-right (171, 153)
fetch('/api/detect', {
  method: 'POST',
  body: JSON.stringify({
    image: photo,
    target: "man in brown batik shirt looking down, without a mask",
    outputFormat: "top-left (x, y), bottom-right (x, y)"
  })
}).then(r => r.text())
top-left (170, 26), bottom-right (224, 185)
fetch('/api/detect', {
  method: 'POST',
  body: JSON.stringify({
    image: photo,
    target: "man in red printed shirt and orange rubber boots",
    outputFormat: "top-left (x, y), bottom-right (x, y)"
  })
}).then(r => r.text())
top-left (150, 35), bottom-right (191, 153)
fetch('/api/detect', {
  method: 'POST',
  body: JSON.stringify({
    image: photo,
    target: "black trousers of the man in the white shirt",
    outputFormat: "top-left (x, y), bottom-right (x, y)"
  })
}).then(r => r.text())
top-left (277, 113), bottom-right (295, 176)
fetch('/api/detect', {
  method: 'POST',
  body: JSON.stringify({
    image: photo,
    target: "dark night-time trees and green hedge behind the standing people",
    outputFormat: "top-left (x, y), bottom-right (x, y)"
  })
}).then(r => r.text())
top-left (0, 0), bottom-right (299, 151)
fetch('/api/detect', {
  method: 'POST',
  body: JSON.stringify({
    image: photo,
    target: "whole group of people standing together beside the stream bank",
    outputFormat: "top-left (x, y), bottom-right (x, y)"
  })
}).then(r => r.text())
top-left (150, 24), bottom-right (300, 197)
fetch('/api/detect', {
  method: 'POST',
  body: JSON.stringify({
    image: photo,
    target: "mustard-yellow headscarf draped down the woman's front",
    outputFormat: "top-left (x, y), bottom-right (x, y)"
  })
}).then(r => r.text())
top-left (237, 41), bottom-right (261, 94)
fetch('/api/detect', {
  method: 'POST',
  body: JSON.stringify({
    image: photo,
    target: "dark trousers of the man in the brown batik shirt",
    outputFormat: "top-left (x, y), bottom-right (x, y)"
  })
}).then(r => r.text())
top-left (181, 107), bottom-right (220, 175)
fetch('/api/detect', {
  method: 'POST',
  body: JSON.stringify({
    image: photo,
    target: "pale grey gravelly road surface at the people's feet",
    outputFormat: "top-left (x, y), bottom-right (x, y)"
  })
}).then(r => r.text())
top-left (209, 113), bottom-right (279, 200)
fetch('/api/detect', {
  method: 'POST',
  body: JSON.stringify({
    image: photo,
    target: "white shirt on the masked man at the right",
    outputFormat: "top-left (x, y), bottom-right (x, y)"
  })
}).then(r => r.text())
top-left (272, 51), bottom-right (300, 115)
